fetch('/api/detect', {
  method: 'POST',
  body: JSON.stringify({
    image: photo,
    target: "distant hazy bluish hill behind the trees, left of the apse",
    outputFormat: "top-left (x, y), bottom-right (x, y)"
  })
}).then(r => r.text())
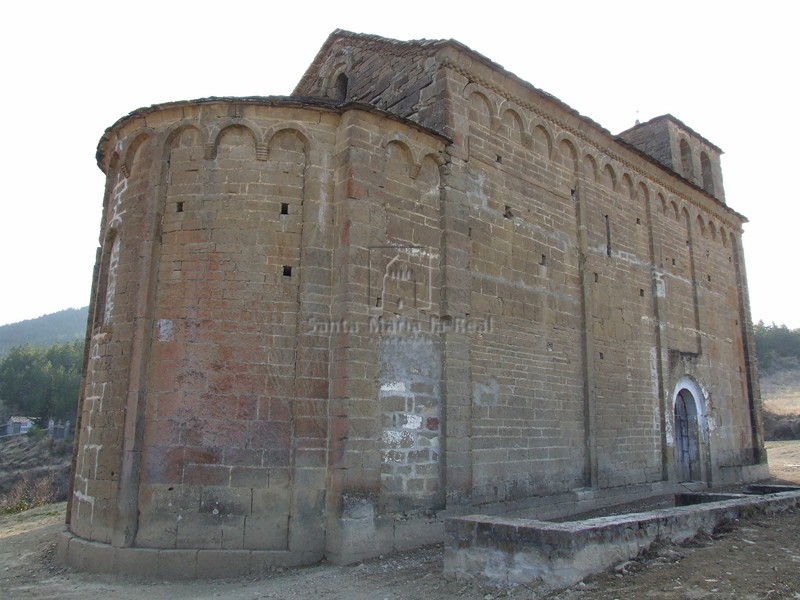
top-left (0, 307), bottom-right (89, 356)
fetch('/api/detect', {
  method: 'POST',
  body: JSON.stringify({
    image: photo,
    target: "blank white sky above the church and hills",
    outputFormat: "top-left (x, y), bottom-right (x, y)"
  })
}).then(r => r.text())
top-left (0, 0), bottom-right (800, 328)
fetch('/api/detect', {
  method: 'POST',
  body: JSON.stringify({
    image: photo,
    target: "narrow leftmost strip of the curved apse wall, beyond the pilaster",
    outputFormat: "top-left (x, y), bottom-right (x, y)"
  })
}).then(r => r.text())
top-left (69, 130), bottom-right (158, 542)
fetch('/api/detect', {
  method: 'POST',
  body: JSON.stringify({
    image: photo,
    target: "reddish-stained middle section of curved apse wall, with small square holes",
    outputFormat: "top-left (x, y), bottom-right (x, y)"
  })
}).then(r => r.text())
top-left (137, 111), bottom-right (334, 551)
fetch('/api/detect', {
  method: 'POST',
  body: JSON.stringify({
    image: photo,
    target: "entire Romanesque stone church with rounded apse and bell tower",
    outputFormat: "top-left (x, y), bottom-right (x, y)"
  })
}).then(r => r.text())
top-left (59, 30), bottom-right (767, 577)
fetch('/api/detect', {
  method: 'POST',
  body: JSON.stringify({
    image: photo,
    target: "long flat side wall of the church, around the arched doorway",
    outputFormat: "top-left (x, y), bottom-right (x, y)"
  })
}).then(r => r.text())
top-left (434, 47), bottom-right (755, 502)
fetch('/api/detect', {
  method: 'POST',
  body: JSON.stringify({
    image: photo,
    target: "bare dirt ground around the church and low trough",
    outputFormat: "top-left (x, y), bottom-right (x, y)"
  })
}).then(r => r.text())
top-left (0, 442), bottom-right (800, 600)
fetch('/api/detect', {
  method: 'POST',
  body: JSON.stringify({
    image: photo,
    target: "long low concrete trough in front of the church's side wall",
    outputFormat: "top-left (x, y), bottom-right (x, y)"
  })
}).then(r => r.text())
top-left (444, 486), bottom-right (800, 587)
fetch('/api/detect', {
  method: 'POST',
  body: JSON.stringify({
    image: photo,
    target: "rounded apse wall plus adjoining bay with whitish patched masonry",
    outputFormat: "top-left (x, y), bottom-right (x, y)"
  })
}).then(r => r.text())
top-left (72, 102), bottom-right (444, 562)
